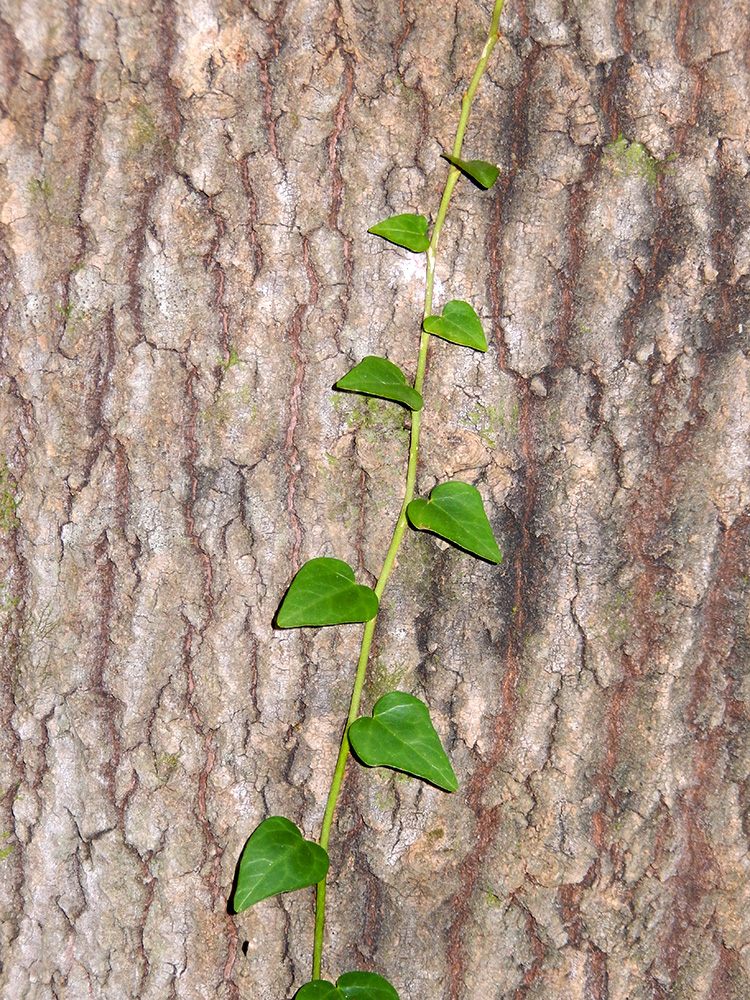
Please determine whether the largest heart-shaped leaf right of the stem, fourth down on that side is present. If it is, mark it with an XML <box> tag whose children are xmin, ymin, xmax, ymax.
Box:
<box><xmin>349</xmin><ymin>691</ymin><xmax>458</xmax><ymax>792</ymax></box>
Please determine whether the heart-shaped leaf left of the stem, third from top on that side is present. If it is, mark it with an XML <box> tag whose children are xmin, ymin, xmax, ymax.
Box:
<box><xmin>276</xmin><ymin>558</ymin><xmax>378</xmax><ymax>628</ymax></box>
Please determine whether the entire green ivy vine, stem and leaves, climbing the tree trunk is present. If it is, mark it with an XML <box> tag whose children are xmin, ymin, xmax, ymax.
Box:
<box><xmin>230</xmin><ymin>0</ymin><xmax>503</xmax><ymax>1000</ymax></box>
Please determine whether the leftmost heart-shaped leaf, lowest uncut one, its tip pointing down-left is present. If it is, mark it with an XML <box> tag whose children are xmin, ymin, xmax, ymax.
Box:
<box><xmin>231</xmin><ymin>816</ymin><xmax>328</xmax><ymax>913</ymax></box>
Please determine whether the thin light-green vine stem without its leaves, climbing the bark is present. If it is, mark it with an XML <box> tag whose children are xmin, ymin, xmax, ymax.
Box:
<box><xmin>313</xmin><ymin>0</ymin><xmax>503</xmax><ymax>979</ymax></box>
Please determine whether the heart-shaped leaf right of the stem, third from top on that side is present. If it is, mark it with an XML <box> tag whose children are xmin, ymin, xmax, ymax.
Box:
<box><xmin>406</xmin><ymin>483</ymin><xmax>503</xmax><ymax>562</ymax></box>
